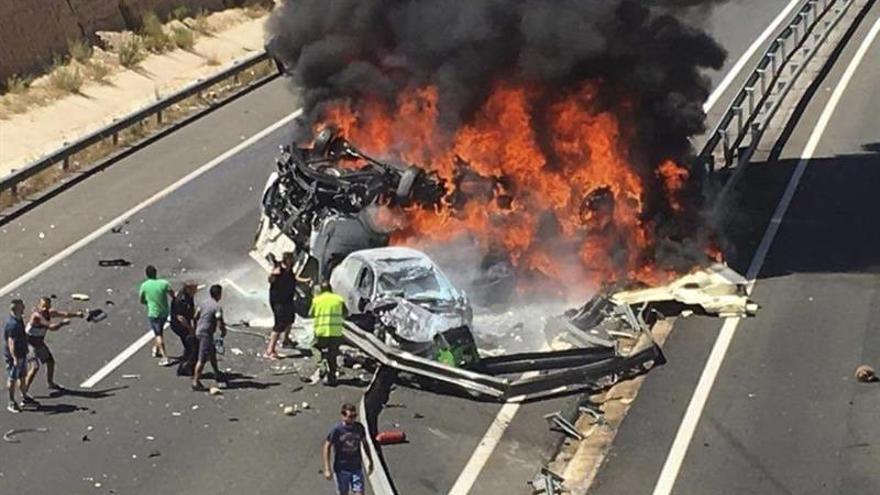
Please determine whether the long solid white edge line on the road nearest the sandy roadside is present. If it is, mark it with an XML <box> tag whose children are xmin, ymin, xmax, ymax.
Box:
<box><xmin>0</xmin><ymin>109</ymin><xmax>302</xmax><ymax>297</ymax></box>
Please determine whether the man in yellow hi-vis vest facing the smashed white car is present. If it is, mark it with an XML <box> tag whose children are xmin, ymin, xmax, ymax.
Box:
<box><xmin>309</xmin><ymin>281</ymin><xmax>345</xmax><ymax>387</ymax></box>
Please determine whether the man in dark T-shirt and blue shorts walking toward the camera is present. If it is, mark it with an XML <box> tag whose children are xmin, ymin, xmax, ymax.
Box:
<box><xmin>323</xmin><ymin>403</ymin><xmax>373</xmax><ymax>495</ymax></box>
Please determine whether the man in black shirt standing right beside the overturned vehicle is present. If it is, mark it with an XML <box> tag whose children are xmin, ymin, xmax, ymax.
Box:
<box><xmin>266</xmin><ymin>251</ymin><xmax>308</xmax><ymax>359</ymax></box>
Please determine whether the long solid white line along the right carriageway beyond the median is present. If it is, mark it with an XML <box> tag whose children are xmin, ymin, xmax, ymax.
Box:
<box><xmin>654</xmin><ymin>19</ymin><xmax>880</xmax><ymax>495</ymax></box>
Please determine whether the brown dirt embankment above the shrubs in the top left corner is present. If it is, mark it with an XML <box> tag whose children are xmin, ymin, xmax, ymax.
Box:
<box><xmin>0</xmin><ymin>0</ymin><xmax>271</xmax><ymax>81</ymax></box>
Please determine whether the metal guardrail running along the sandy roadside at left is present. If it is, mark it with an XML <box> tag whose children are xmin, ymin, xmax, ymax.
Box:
<box><xmin>0</xmin><ymin>51</ymin><xmax>271</xmax><ymax>198</ymax></box>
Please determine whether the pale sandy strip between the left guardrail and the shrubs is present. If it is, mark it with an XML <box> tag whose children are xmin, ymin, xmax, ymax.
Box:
<box><xmin>0</xmin><ymin>11</ymin><xmax>266</xmax><ymax>177</ymax></box>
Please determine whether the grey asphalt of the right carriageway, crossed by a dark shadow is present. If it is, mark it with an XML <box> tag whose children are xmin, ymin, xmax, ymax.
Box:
<box><xmin>591</xmin><ymin>4</ymin><xmax>880</xmax><ymax>495</ymax></box>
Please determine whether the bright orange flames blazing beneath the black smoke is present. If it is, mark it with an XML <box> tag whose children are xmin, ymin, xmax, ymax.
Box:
<box><xmin>316</xmin><ymin>83</ymin><xmax>688</xmax><ymax>286</ymax></box>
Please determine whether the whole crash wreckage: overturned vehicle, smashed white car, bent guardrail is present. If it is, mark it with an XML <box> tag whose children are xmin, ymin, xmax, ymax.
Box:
<box><xmin>251</xmin><ymin>127</ymin><xmax>758</xmax><ymax>402</ymax></box>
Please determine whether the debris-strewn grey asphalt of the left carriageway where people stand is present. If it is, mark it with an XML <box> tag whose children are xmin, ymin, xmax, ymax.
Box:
<box><xmin>0</xmin><ymin>0</ymin><xmax>820</xmax><ymax>495</ymax></box>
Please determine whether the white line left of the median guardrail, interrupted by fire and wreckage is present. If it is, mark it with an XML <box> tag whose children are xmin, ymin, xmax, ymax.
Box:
<box><xmin>449</xmin><ymin>0</ymin><xmax>801</xmax><ymax>495</ymax></box>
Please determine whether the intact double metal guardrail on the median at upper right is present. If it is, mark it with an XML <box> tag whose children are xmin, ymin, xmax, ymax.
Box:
<box><xmin>699</xmin><ymin>0</ymin><xmax>855</xmax><ymax>174</ymax></box>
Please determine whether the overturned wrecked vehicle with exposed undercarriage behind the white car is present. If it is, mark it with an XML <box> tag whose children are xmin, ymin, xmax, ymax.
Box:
<box><xmin>251</xmin><ymin>127</ymin><xmax>445</xmax><ymax>294</ymax></box>
